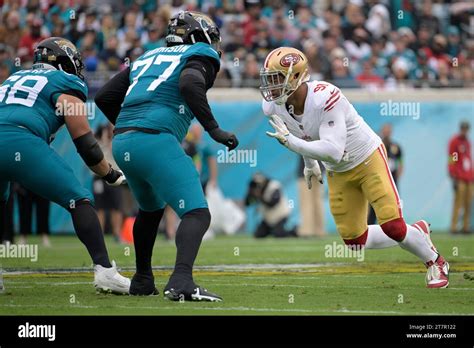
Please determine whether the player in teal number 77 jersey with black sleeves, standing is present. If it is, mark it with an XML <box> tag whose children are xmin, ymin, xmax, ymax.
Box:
<box><xmin>95</xmin><ymin>11</ymin><xmax>238</xmax><ymax>301</ymax></box>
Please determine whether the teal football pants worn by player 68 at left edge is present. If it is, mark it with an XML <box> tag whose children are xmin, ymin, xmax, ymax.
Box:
<box><xmin>0</xmin><ymin>126</ymin><xmax>94</xmax><ymax>209</ymax></box>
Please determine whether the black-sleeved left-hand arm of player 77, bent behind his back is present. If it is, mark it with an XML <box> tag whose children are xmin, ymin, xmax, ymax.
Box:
<box><xmin>94</xmin><ymin>67</ymin><xmax>130</xmax><ymax>125</ymax></box>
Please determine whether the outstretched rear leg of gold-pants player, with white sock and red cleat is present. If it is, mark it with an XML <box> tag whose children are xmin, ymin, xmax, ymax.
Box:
<box><xmin>361</xmin><ymin>146</ymin><xmax>448</xmax><ymax>287</ymax></box>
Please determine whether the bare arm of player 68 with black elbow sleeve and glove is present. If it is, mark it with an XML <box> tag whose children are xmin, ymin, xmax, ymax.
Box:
<box><xmin>57</xmin><ymin>94</ymin><xmax>125</xmax><ymax>185</ymax></box>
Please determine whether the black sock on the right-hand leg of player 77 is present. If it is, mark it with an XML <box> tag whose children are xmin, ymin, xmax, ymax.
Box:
<box><xmin>166</xmin><ymin>208</ymin><xmax>211</xmax><ymax>289</ymax></box>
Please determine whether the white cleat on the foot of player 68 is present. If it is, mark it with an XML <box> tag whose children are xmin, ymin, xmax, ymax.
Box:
<box><xmin>94</xmin><ymin>261</ymin><xmax>130</xmax><ymax>294</ymax></box>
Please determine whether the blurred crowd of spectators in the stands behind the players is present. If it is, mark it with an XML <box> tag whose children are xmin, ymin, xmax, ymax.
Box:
<box><xmin>0</xmin><ymin>0</ymin><xmax>474</xmax><ymax>92</ymax></box>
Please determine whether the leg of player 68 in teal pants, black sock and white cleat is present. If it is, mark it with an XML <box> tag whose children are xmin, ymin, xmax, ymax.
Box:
<box><xmin>1</xmin><ymin>133</ymin><xmax>130</xmax><ymax>293</ymax></box>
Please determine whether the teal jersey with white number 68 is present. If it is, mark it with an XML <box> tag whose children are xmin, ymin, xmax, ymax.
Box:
<box><xmin>0</xmin><ymin>69</ymin><xmax>87</xmax><ymax>142</ymax></box>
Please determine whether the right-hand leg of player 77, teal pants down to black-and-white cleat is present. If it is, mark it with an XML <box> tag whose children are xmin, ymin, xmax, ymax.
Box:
<box><xmin>149</xmin><ymin>134</ymin><xmax>221</xmax><ymax>301</ymax></box>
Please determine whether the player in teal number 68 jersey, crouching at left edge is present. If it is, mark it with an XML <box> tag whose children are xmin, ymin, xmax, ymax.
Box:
<box><xmin>0</xmin><ymin>37</ymin><xmax>130</xmax><ymax>293</ymax></box>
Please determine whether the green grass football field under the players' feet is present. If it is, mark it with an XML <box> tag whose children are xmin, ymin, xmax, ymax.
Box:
<box><xmin>0</xmin><ymin>234</ymin><xmax>474</xmax><ymax>315</ymax></box>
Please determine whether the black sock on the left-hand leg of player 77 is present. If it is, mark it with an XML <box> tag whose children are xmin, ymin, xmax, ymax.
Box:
<box><xmin>133</xmin><ymin>209</ymin><xmax>165</xmax><ymax>274</ymax></box>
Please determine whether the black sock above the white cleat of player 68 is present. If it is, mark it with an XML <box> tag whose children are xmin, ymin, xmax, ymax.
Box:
<box><xmin>70</xmin><ymin>201</ymin><xmax>112</xmax><ymax>268</ymax></box>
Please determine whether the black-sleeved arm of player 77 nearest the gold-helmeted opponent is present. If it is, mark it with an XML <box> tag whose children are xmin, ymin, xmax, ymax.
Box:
<box><xmin>179</xmin><ymin>56</ymin><xmax>239</xmax><ymax>150</ymax></box>
